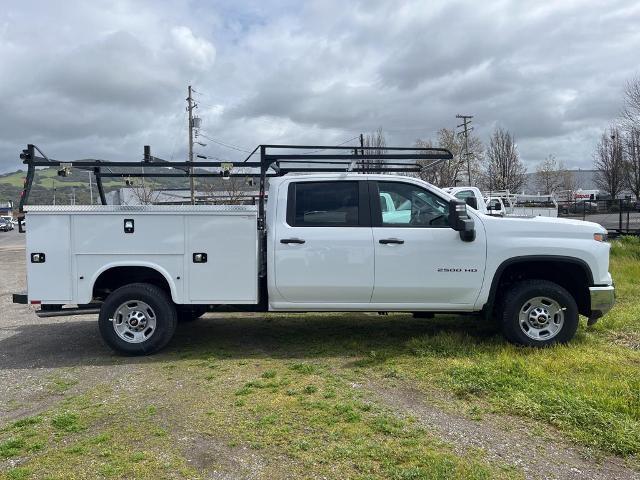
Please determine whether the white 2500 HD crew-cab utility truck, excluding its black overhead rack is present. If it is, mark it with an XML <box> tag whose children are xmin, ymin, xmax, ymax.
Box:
<box><xmin>14</xmin><ymin>144</ymin><xmax>614</xmax><ymax>354</ymax></box>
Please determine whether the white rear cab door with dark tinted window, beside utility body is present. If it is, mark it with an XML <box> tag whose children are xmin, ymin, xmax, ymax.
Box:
<box><xmin>273</xmin><ymin>180</ymin><xmax>374</xmax><ymax>308</ymax></box>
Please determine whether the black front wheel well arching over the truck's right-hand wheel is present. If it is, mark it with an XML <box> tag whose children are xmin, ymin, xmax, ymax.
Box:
<box><xmin>490</xmin><ymin>259</ymin><xmax>592</xmax><ymax>316</ymax></box>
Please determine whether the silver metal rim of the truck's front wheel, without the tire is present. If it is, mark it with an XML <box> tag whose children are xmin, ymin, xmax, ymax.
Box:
<box><xmin>518</xmin><ymin>297</ymin><xmax>565</xmax><ymax>340</ymax></box>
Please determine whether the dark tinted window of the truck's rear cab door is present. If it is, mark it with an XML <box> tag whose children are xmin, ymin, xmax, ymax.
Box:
<box><xmin>288</xmin><ymin>182</ymin><xmax>359</xmax><ymax>227</ymax></box>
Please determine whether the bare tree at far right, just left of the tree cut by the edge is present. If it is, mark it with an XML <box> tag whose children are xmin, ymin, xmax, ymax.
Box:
<box><xmin>594</xmin><ymin>127</ymin><xmax>625</xmax><ymax>198</ymax></box>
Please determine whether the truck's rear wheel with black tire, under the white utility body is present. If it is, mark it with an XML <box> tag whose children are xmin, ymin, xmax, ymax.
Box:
<box><xmin>98</xmin><ymin>283</ymin><xmax>177</xmax><ymax>355</ymax></box>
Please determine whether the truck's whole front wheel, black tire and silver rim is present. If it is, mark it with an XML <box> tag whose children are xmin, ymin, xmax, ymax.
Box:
<box><xmin>499</xmin><ymin>280</ymin><xmax>578</xmax><ymax>347</ymax></box>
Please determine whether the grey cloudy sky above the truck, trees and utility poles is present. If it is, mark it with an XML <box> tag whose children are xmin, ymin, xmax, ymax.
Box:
<box><xmin>0</xmin><ymin>0</ymin><xmax>640</xmax><ymax>172</ymax></box>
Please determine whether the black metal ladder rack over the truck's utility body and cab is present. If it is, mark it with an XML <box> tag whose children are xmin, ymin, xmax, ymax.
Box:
<box><xmin>19</xmin><ymin>144</ymin><xmax>453</xmax><ymax>218</ymax></box>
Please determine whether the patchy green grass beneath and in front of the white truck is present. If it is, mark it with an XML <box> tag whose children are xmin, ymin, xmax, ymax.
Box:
<box><xmin>0</xmin><ymin>238</ymin><xmax>640</xmax><ymax>479</ymax></box>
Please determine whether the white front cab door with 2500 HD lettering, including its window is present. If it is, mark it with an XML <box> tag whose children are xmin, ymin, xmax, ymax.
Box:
<box><xmin>370</xmin><ymin>181</ymin><xmax>486</xmax><ymax>310</ymax></box>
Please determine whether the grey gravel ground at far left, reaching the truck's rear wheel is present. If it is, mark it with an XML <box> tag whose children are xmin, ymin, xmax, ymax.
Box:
<box><xmin>0</xmin><ymin>230</ymin><xmax>127</xmax><ymax>424</ymax></box>
